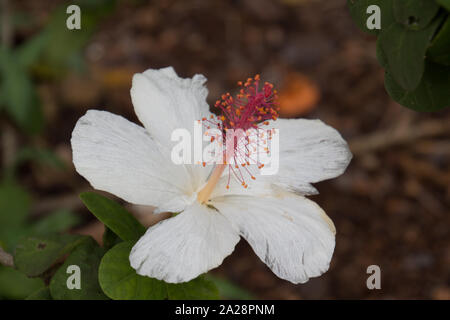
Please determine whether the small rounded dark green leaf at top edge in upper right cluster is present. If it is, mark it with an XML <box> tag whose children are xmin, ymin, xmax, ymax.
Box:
<box><xmin>393</xmin><ymin>0</ymin><xmax>439</xmax><ymax>30</ymax></box>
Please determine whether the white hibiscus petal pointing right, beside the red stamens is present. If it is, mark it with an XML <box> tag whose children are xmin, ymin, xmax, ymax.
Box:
<box><xmin>212</xmin><ymin>119</ymin><xmax>352</xmax><ymax>197</ymax></box>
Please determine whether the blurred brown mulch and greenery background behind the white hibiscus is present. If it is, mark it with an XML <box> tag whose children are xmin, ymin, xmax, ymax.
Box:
<box><xmin>0</xmin><ymin>0</ymin><xmax>450</xmax><ymax>299</ymax></box>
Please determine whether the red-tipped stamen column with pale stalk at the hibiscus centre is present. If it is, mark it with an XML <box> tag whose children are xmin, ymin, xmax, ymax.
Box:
<box><xmin>197</xmin><ymin>75</ymin><xmax>280</xmax><ymax>203</ymax></box>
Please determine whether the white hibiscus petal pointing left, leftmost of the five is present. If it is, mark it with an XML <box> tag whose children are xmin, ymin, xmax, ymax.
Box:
<box><xmin>71</xmin><ymin>110</ymin><xmax>193</xmax><ymax>212</ymax></box>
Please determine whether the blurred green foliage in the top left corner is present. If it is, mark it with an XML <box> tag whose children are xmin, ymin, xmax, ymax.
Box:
<box><xmin>0</xmin><ymin>0</ymin><xmax>116</xmax><ymax>134</ymax></box>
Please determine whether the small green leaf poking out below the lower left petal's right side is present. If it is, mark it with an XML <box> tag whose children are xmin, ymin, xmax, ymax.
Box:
<box><xmin>166</xmin><ymin>276</ymin><xmax>220</xmax><ymax>300</ymax></box>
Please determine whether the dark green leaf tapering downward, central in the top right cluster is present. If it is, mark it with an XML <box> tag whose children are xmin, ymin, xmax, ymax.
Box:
<box><xmin>378</xmin><ymin>19</ymin><xmax>440</xmax><ymax>90</ymax></box>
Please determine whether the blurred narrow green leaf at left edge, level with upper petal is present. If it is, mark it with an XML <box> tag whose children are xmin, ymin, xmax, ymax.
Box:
<box><xmin>0</xmin><ymin>48</ymin><xmax>43</xmax><ymax>134</ymax></box>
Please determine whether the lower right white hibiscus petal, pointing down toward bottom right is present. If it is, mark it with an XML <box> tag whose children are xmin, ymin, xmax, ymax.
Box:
<box><xmin>211</xmin><ymin>193</ymin><xmax>335</xmax><ymax>283</ymax></box>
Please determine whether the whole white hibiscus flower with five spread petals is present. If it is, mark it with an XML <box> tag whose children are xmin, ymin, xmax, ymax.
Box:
<box><xmin>71</xmin><ymin>68</ymin><xmax>351</xmax><ymax>283</ymax></box>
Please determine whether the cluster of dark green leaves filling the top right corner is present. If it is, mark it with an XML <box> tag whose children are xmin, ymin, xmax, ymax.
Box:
<box><xmin>347</xmin><ymin>0</ymin><xmax>450</xmax><ymax>111</ymax></box>
